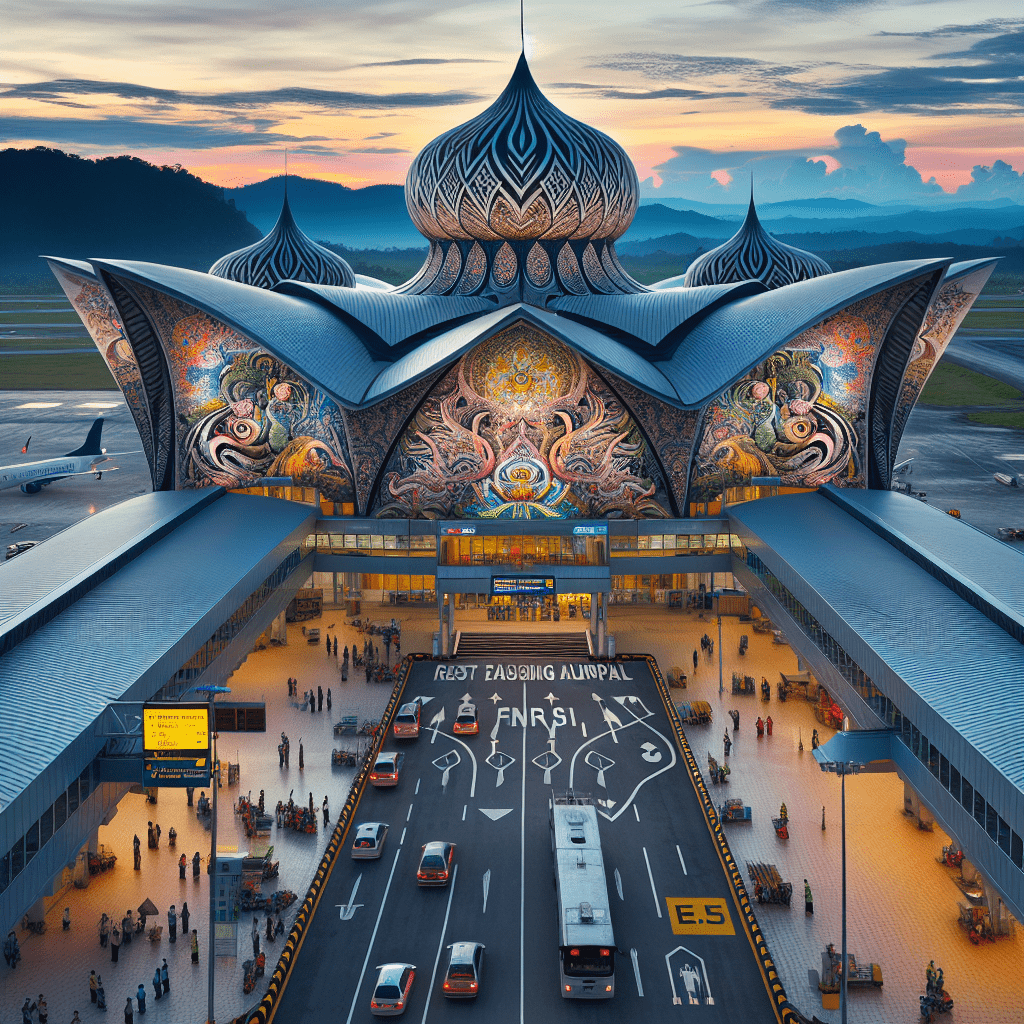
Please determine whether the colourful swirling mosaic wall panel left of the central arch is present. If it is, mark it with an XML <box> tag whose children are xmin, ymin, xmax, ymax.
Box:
<box><xmin>121</xmin><ymin>285</ymin><xmax>354</xmax><ymax>502</ymax></box>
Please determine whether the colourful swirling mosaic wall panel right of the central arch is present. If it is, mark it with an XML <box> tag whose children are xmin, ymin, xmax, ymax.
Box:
<box><xmin>688</xmin><ymin>283</ymin><xmax>912</xmax><ymax>502</ymax></box>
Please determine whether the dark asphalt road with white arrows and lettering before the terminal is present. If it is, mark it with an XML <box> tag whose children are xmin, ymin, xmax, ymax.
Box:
<box><xmin>274</xmin><ymin>662</ymin><xmax>770</xmax><ymax>1024</ymax></box>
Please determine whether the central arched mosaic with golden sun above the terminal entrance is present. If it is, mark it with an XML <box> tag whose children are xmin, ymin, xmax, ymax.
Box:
<box><xmin>373</xmin><ymin>322</ymin><xmax>670</xmax><ymax>519</ymax></box>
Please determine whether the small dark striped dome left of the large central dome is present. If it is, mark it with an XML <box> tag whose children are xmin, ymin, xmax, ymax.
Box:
<box><xmin>210</xmin><ymin>191</ymin><xmax>355</xmax><ymax>289</ymax></box>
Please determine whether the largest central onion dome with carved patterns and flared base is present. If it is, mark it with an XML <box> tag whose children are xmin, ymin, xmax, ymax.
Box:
<box><xmin>399</xmin><ymin>56</ymin><xmax>645</xmax><ymax>301</ymax></box>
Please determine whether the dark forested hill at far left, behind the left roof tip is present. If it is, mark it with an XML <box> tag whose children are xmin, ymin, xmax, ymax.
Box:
<box><xmin>0</xmin><ymin>146</ymin><xmax>260</xmax><ymax>289</ymax></box>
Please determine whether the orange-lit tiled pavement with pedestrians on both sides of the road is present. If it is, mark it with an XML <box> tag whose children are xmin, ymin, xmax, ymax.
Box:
<box><xmin>0</xmin><ymin>601</ymin><xmax>1024</xmax><ymax>1024</ymax></box>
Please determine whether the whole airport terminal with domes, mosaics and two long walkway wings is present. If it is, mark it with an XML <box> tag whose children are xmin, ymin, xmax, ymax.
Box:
<box><xmin>0</xmin><ymin>58</ymin><xmax>1024</xmax><ymax>942</ymax></box>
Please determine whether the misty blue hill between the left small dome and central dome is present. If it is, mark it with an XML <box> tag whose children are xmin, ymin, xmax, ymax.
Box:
<box><xmin>224</xmin><ymin>175</ymin><xmax>426</xmax><ymax>249</ymax></box>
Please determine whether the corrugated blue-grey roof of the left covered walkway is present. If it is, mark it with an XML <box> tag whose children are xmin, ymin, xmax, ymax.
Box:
<box><xmin>0</xmin><ymin>488</ymin><xmax>318</xmax><ymax>806</ymax></box>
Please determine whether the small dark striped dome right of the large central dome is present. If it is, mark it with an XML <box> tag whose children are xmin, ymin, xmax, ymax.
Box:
<box><xmin>683</xmin><ymin>194</ymin><xmax>833</xmax><ymax>288</ymax></box>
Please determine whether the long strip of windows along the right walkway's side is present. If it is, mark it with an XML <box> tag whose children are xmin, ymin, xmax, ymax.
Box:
<box><xmin>746</xmin><ymin>551</ymin><xmax>1024</xmax><ymax>870</ymax></box>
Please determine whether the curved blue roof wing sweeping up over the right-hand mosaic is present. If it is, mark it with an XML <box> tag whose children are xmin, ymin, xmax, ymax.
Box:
<box><xmin>658</xmin><ymin>259</ymin><xmax>950</xmax><ymax>407</ymax></box>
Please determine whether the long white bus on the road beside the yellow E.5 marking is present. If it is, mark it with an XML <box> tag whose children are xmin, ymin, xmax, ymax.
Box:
<box><xmin>551</xmin><ymin>794</ymin><xmax>615</xmax><ymax>999</ymax></box>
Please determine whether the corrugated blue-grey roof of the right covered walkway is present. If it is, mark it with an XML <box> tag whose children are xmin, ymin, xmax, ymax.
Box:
<box><xmin>729</xmin><ymin>491</ymin><xmax>1024</xmax><ymax>788</ymax></box>
